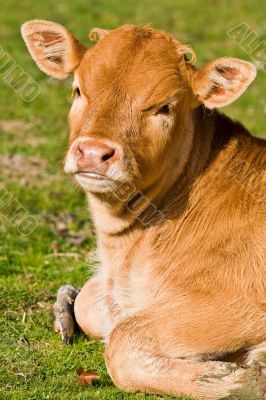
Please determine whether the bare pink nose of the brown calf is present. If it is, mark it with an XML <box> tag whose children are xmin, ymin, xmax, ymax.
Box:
<box><xmin>74</xmin><ymin>140</ymin><xmax>116</xmax><ymax>174</ymax></box>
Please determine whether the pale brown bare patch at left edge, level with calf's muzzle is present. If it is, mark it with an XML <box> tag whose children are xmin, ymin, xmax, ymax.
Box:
<box><xmin>0</xmin><ymin>154</ymin><xmax>51</xmax><ymax>186</ymax></box>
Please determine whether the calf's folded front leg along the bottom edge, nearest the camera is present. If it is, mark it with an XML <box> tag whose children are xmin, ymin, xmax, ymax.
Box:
<box><xmin>105</xmin><ymin>299</ymin><xmax>264</xmax><ymax>400</ymax></box>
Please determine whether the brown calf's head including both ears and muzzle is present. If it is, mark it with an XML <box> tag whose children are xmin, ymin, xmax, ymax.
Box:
<box><xmin>22</xmin><ymin>20</ymin><xmax>256</xmax><ymax>195</ymax></box>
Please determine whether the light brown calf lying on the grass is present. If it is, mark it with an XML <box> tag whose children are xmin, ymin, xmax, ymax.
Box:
<box><xmin>22</xmin><ymin>20</ymin><xmax>266</xmax><ymax>400</ymax></box>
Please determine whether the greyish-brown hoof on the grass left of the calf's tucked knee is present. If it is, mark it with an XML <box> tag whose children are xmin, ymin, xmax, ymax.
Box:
<box><xmin>53</xmin><ymin>285</ymin><xmax>79</xmax><ymax>344</ymax></box>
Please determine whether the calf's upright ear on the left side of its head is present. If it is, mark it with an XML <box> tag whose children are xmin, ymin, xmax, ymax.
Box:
<box><xmin>21</xmin><ymin>20</ymin><xmax>86</xmax><ymax>79</ymax></box>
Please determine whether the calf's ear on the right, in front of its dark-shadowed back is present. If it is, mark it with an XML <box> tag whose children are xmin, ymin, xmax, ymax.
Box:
<box><xmin>192</xmin><ymin>57</ymin><xmax>256</xmax><ymax>108</ymax></box>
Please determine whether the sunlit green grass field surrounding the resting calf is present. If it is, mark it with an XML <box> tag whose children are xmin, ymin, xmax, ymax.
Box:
<box><xmin>0</xmin><ymin>0</ymin><xmax>266</xmax><ymax>400</ymax></box>
